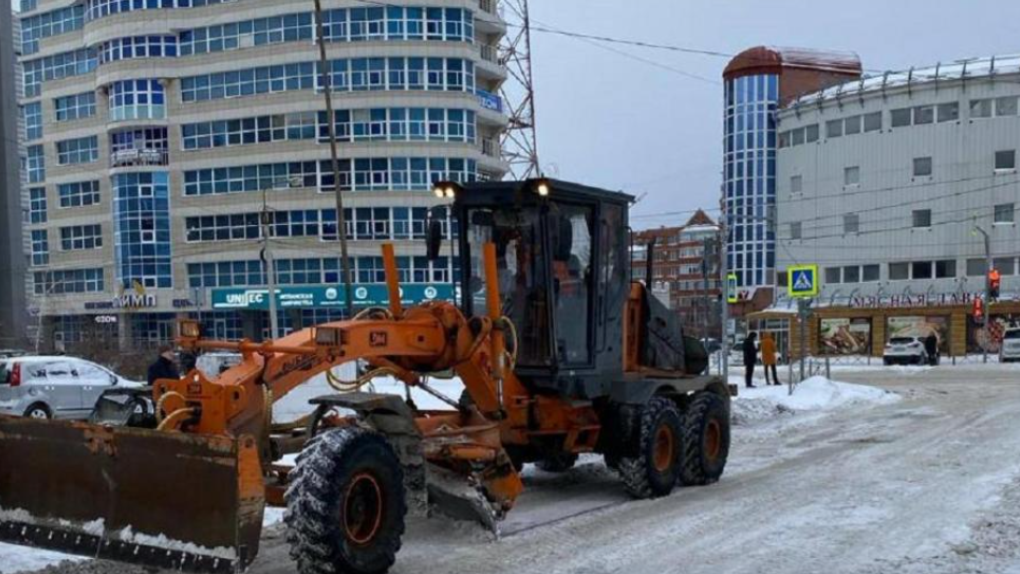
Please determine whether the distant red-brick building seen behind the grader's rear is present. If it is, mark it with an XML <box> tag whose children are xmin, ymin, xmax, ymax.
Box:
<box><xmin>631</xmin><ymin>210</ymin><xmax>722</xmax><ymax>337</ymax></box>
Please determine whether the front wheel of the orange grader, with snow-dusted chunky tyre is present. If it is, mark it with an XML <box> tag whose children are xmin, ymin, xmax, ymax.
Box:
<box><xmin>284</xmin><ymin>427</ymin><xmax>407</xmax><ymax>574</ymax></box>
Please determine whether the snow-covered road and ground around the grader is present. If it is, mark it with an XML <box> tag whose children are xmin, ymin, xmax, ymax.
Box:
<box><xmin>11</xmin><ymin>365</ymin><xmax>1020</xmax><ymax>574</ymax></box>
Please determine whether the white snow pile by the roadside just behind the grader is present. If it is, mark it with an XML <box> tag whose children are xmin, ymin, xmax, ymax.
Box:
<box><xmin>732</xmin><ymin>376</ymin><xmax>900</xmax><ymax>424</ymax></box>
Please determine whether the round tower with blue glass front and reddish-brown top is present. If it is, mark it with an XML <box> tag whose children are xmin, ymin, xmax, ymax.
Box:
<box><xmin>722</xmin><ymin>46</ymin><xmax>861</xmax><ymax>315</ymax></box>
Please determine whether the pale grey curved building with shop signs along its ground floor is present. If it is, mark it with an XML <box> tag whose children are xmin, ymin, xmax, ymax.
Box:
<box><xmin>766</xmin><ymin>56</ymin><xmax>1020</xmax><ymax>356</ymax></box>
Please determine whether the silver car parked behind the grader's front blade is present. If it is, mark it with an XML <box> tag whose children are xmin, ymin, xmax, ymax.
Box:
<box><xmin>0</xmin><ymin>356</ymin><xmax>142</xmax><ymax>419</ymax></box>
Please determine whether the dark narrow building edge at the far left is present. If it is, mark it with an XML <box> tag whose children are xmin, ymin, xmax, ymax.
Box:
<box><xmin>0</xmin><ymin>7</ymin><xmax>28</xmax><ymax>347</ymax></box>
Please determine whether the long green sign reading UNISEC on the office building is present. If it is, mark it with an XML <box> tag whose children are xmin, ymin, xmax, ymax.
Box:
<box><xmin>212</xmin><ymin>284</ymin><xmax>455</xmax><ymax>311</ymax></box>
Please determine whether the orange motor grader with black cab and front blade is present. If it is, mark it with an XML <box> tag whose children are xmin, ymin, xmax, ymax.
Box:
<box><xmin>0</xmin><ymin>179</ymin><xmax>731</xmax><ymax>574</ymax></box>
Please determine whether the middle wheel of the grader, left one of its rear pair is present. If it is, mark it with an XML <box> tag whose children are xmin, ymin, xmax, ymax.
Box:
<box><xmin>619</xmin><ymin>397</ymin><xmax>683</xmax><ymax>499</ymax></box>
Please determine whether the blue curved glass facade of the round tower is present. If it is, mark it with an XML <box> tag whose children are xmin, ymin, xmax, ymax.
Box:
<box><xmin>723</xmin><ymin>74</ymin><xmax>779</xmax><ymax>288</ymax></box>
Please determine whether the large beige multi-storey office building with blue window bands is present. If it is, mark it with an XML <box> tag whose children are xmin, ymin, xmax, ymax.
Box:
<box><xmin>20</xmin><ymin>0</ymin><xmax>508</xmax><ymax>343</ymax></box>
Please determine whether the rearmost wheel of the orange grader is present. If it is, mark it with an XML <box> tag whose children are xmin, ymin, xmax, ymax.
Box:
<box><xmin>680</xmin><ymin>392</ymin><xmax>729</xmax><ymax>486</ymax></box>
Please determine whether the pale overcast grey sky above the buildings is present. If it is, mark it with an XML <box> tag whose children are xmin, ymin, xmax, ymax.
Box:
<box><xmin>12</xmin><ymin>0</ymin><xmax>1020</xmax><ymax>227</ymax></box>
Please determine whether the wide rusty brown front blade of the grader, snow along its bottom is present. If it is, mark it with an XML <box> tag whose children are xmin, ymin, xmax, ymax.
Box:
<box><xmin>0</xmin><ymin>416</ymin><xmax>265</xmax><ymax>573</ymax></box>
